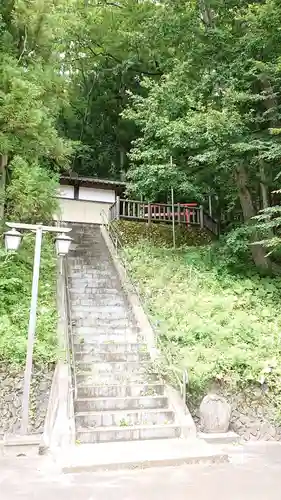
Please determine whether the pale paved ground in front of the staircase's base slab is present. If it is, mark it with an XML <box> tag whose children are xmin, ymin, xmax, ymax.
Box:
<box><xmin>0</xmin><ymin>443</ymin><xmax>281</xmax><ymax>500</ymax></box>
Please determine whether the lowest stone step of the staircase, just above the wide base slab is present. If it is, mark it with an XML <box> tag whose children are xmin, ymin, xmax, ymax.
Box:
<box><xmin>76</xmin><ymin>424</ymin><xmax>181</xmax><ymax>444</ymax></box>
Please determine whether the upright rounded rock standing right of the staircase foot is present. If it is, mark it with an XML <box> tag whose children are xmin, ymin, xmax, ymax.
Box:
<box><xmin>200</xmin><ymin>394</ymin><xmax>231</xmax><ymax>433</ymax></box>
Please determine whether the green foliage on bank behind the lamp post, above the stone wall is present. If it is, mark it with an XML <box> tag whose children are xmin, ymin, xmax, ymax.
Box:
<box><xmin>0</xmin><ymin>235</ymin><xmax>57</xmax><ymax>366</ymax></box>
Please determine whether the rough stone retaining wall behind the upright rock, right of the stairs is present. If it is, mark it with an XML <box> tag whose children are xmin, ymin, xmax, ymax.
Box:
<box><xmin>191</xmin><ymin>389</ymin><xmax>281</xmax><ymax>441</ymax></box>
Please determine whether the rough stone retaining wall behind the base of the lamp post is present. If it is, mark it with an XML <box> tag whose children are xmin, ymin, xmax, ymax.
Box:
<box><xmin>0</xmin><ymin>365</ymin><xmax>54</xmax><ymax>435</ymax></box>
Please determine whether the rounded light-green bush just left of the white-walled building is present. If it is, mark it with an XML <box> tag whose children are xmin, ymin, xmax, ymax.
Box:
<box><xmin>6</xmin><ymin>157</ymin><xmax>58</xmax><ymax>224</ymax></box>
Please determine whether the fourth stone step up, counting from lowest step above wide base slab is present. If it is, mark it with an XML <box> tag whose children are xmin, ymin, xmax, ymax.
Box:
<box><xmin>77</xmin><ymin>382</ymin><xmax>165</xmax><ymax>398</ymax></box>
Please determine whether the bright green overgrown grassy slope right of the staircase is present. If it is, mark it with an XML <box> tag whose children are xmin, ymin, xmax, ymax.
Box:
<box><xmin>125</xmin><ymin>242</ymin><xmax>281</xmax><ymax>414</ymax></box>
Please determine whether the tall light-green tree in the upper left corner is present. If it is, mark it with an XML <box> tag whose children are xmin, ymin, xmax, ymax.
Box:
<box><xmin>0</xmin><ymin>0</ymin><xmax>75</xmax><ymax>216</ymax></box>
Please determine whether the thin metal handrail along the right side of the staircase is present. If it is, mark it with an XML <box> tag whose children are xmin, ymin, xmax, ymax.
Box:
<box><xmin>100</xmin><ymin>210</ymin><xmax>189</xmax><ymax>405</ymax></box>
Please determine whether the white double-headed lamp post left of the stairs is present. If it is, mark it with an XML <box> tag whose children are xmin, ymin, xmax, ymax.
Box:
<box><xmin>4</xmin><ymin>222</ymin><xmax>72</xmax><ymax>434</ymax></box>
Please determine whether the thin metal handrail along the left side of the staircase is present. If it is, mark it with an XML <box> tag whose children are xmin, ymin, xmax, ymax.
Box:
<box><xmin>63</xmin><ymin>257</ymin><xmax>77</xmax><ymax>400</ymax></box>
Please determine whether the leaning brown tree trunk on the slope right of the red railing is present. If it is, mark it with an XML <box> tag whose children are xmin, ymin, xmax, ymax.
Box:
<box><xmin>236</xmin><ymin>166</ymin><xmax>271</xmax><ymax>271</ymax></box>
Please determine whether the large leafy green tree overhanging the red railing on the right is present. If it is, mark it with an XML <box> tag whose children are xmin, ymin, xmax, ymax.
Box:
<box><xmin>125</xmin><ymin>0</ymin><xmax>281</xmax><ymax>268</ymax></box>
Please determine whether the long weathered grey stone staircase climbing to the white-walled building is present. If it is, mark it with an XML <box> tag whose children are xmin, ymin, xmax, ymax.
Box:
<box><xmin>69</xmin><ymin>225</ymin><xmax>182</xmax><ymax>443</ymax></box>
